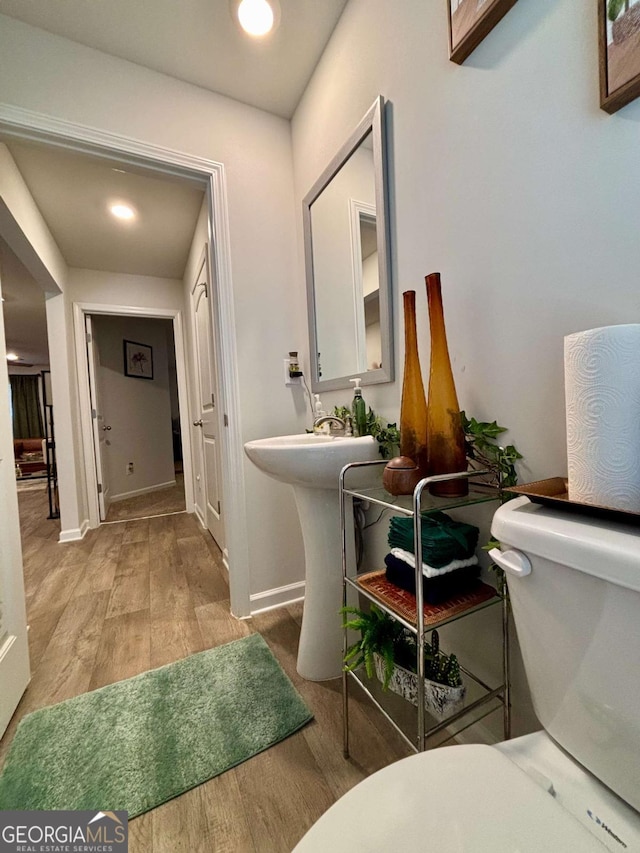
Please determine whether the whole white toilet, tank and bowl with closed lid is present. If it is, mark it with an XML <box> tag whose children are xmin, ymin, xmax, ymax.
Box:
<box><xmin>295</xmin><ymin>497</ymin><xmax>640</xmax><ymax>853</ymax></box>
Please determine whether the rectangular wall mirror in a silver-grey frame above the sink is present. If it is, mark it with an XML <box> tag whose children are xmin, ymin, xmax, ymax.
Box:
<box><xmin>303</xmin><ymin>97</ymin><xmax>394</xmax><ymax>391</ymax></box>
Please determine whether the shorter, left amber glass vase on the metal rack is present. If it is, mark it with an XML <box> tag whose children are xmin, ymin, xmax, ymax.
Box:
<box><xmin>400</xmin><ymin>290</ymin><xmax>427</xmax><ymax>477</ymax></box>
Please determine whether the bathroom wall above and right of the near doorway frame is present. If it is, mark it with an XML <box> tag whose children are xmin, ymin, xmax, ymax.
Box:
<box><xmin>0</xmin><ymin>16</ymin><xmax>310</xmax><ymax>592</ymax></box>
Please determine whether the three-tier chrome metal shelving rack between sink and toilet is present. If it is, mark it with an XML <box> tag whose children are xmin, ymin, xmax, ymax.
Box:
<box><xmin>340</xmin><ymin>460</ymin><xmax>511</xmax><ymax>757</ymax></box>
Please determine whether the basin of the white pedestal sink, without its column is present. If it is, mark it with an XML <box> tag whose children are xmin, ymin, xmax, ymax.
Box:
<box><xmin>244</xmin><ymin>433</ymin><xmax>379</xmax><ymax>489</ymax></box>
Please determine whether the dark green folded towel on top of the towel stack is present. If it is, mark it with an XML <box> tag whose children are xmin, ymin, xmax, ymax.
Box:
<box><xmin>388</xmin><ymin>512</ymin><xmax>480</xmax><ymax>569</ymax></box>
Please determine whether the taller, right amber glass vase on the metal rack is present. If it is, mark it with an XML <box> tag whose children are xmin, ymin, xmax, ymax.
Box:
<box><xmin>425</xmin><ymin>272</ymin><xmax>469</xmax><ymax>497</ymax></box>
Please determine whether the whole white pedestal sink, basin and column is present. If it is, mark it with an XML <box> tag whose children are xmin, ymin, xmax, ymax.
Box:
<box><xmin>244</xmin><ymin>434</ymin><xmax>379</xmax><ymax>681</ymax></box>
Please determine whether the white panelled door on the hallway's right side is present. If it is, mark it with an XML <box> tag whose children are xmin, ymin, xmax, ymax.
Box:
<box><xmin>191</xmin><ymin>247</ymin><xmax>224</xmax><ymax>550</ymax></box>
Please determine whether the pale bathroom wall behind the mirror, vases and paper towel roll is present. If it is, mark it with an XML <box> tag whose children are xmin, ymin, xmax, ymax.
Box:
<box><xmin>292</xmin><ymin>0</ymin><xmax>640</xmax><ymax>732</ymax></box>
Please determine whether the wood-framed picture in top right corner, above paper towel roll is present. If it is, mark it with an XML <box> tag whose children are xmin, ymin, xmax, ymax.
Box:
<box><xmin>598</xmin><ymin>0</ymin><xmax>640</xmax><ymax>113</ymax></box>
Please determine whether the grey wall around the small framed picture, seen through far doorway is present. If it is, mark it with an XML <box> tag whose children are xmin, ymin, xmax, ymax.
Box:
<box><xmin>92</xmin><ymin>315</ymin><xmax>175</xmax><ymax>500</ymax></box>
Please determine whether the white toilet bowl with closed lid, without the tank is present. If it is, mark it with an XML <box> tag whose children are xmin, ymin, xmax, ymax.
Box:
<box><xmin>294</xmin><ymin>732</ymin><xmax>640</xmax><ymax>853</ymax></box>
